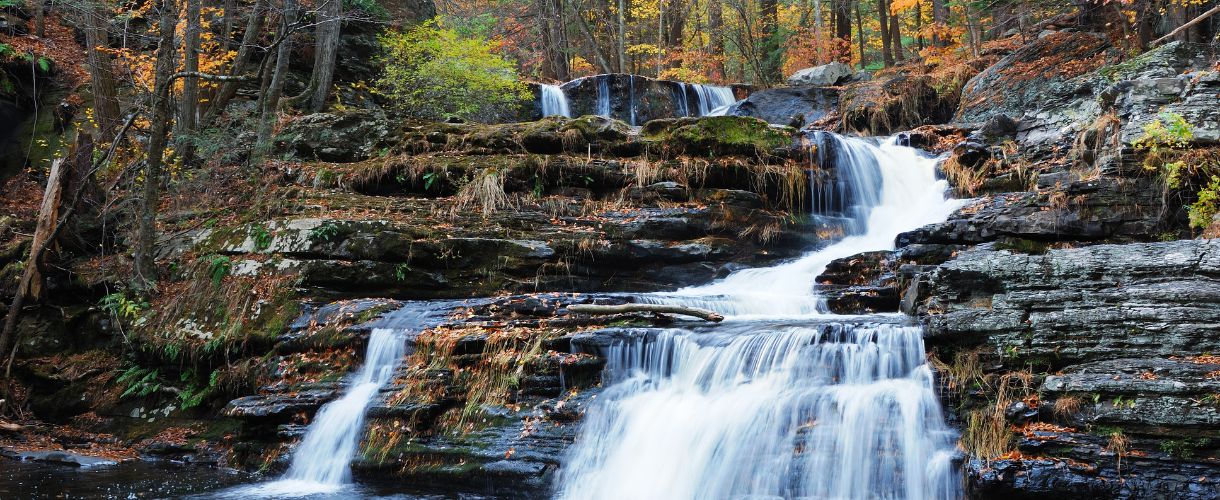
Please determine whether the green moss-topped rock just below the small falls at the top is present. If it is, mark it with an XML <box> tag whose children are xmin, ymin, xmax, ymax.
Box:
<box><xmin>641</xmin><ymin>116</ymin><xmax>795</xmax><ymax>156</ymax></box>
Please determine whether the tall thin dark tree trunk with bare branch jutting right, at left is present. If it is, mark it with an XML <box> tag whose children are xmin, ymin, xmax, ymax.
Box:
<box><xmin>133</xmin><ymin>0</ymin><xmax>178</xmax><ymax>290</ymax></box>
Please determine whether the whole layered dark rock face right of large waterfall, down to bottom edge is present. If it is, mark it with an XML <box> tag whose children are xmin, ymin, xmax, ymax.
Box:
<box><xmin>915</xmin><ymin>240</ymin><xmax>1220</xmax><ymax>499</ymax></box>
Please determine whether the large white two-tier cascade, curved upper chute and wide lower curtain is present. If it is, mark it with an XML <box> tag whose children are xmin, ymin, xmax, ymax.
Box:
<box><xmin>556</xmin><ymin>131</ymin><xmax>960</xmax><ymax>499</ymax></box>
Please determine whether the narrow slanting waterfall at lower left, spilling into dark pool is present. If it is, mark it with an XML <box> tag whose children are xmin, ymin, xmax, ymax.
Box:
<box><xmin>217</xmin><ymin>301</ymin><xmax>451</xmax><ymax>498</ymax></box>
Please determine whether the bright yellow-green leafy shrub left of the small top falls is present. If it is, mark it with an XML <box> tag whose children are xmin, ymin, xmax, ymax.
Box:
<box><xmin>377</xmin><ymin>20</ymin><xmax>532</xmax><ymax>122</ymax></box>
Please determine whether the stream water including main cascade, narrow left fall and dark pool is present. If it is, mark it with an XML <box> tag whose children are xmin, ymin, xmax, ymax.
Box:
<box><xmin>0</xmin><ymin>131</ymin><xmax>961</xmax><ymax>499</ymax></box>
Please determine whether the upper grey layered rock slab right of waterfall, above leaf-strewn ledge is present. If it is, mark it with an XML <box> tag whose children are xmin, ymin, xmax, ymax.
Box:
<box><xmin>925</xmin><ymin>240</ymin><xmax>1220</xmax><ymax>367</ymax></box>
